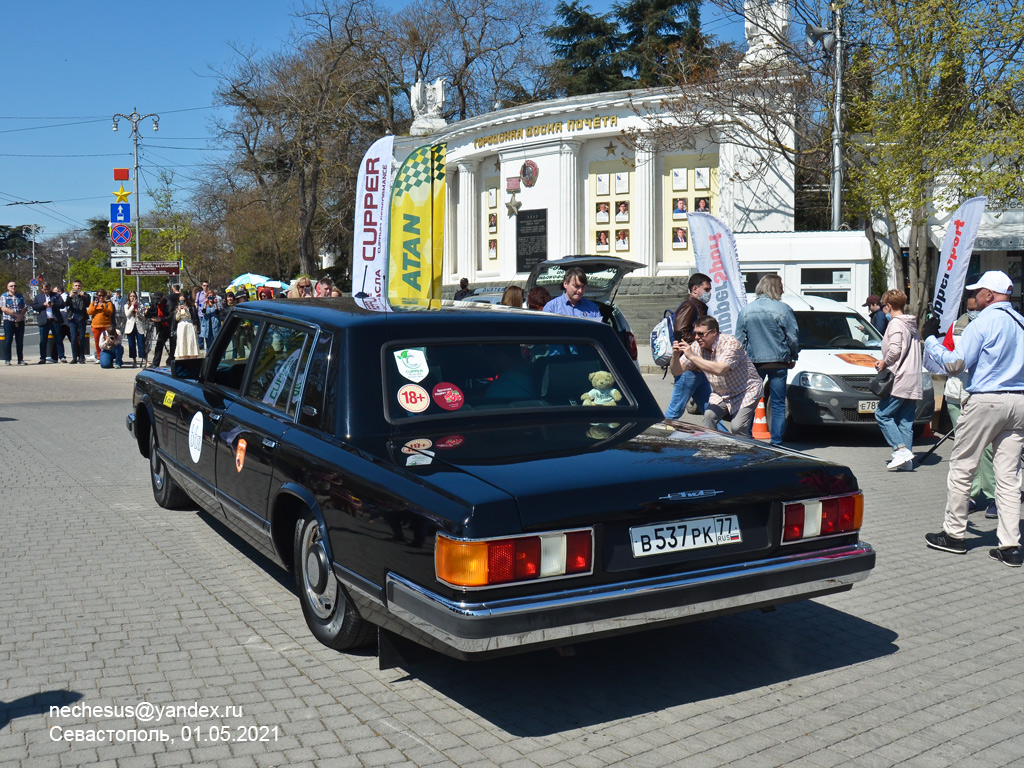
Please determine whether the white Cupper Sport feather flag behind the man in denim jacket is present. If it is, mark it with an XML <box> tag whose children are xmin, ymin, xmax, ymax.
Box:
<box><xmin>688</xmin><ymin>212</ymin><xmax>746</xmax><ymax>334</ymax></box>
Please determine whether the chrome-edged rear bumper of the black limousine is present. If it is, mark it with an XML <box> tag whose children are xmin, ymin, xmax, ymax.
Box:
<box><xmin>385</xmin><ymin>542</ymin><xmax>874</xmax><ymax>657</ymax></box>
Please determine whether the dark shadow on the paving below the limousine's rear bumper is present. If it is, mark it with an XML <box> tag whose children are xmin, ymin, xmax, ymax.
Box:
<box><xmin>407</xmin><ymin>601</ymin><xmax>898</xmax><ymax>736</ymax></box>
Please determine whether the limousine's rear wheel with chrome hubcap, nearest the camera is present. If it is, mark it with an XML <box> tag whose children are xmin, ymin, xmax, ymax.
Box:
<box><xmin>294</xmin><ymin>512</ymin><xmax>377</xmax><ymax>650</ymax></box>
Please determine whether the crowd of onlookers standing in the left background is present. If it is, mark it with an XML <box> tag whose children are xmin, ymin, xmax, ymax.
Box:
<box><xmin>0</xmin><ymin>274</ymin><xmax>341</xmax><ymax>369</ymax></box>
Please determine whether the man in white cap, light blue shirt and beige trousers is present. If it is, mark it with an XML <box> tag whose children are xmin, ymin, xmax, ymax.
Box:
<box><xmin>923</xmin><ymin>271</ymin><xmax>1024</xmax><ymax>567</ymax></box>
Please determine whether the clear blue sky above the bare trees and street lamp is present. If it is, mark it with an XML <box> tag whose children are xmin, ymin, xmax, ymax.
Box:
<box><xmin>0</xmin><ymin>0</ymin><xmax>742</xmax><ymax>239</ymax></box>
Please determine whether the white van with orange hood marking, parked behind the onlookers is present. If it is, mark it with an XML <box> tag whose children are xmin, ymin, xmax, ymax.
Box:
<box><xmin>770</xmin><ymin>293</ymin><xmax>935</xmax><ymax>435</ymax></box>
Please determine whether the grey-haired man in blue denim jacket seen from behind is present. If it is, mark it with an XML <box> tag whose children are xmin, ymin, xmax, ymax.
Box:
<box><xmin>736</xmin><ymin>274</ymin><xmax>800</xmax><ymax>445</ymax></box>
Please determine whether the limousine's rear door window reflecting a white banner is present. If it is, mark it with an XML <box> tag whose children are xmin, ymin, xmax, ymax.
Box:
<box><xmin>246</xmin><ymin>324</ymin><xmax>311</xmax><ymax>416</ymax></box>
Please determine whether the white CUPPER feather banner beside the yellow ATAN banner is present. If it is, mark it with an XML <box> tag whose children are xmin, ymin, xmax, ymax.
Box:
<box><xmin>352</xmin><ymin>136</ymin><xmax>394</xmax><ymax>312</ymax></box>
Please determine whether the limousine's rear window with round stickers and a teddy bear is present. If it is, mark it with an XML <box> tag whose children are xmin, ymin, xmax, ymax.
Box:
<box><xmin>384</xmin><ymin>340</ymin><xmax>635</xmax><ymax>421</ymax></box>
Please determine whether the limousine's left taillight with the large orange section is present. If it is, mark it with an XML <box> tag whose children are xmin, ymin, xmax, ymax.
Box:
<box><xmin>434</xmin><ymin>528</ymin><xmax>594</xmax><ymax>587</ymax></box>
